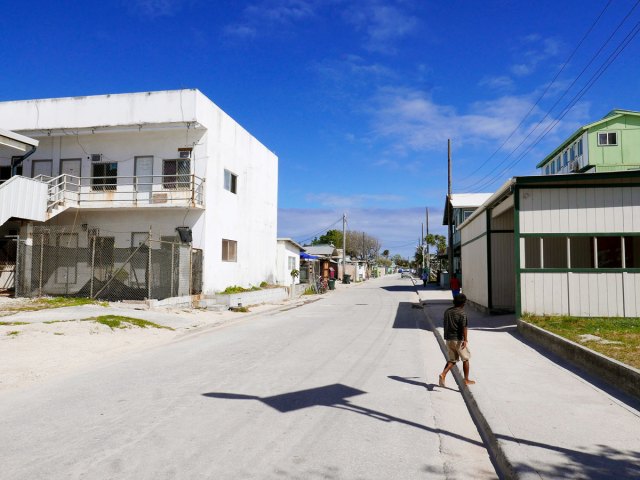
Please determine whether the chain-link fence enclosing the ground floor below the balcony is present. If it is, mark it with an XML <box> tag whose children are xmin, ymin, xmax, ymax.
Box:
<box><xmin>15</xmin><ymin>226</ymin><xmax>202</xmax><ymax>301</ymax></box>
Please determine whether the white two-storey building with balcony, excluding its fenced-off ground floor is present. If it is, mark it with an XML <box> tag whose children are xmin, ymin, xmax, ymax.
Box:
<box><xmin>0</xmin><ymin>89</ymin><xmax>278</xmax><ymax>293</ymax></box>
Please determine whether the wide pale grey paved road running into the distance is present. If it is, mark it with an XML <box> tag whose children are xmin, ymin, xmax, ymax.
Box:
<box><xmin>0</xmin><ymin>276</ymin><xmax>496</xmax><ymax>480</ymax></box>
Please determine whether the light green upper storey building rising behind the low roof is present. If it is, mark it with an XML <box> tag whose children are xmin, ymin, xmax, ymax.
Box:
<box><xmin>536</xmin><ymin>110</ymin><xmax>640</xmax><ymax>175</ymax></box>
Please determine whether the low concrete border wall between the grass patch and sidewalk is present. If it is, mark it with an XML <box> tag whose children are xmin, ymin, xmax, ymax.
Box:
<box><xmin>517</xmin><ymin>319</ymin><xmax>640</xmax><ymax>401</ymax></box>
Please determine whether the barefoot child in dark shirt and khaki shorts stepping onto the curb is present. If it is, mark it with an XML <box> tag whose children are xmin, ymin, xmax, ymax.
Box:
<box><xmin>438</xmin><ymin>293</ymin><xmax>476</xmax><ymax>387</ymax></box>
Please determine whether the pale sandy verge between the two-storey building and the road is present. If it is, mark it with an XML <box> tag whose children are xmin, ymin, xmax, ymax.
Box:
<box><xmin>0</xmin><ymin>296</ymin><xmax>314</xmax><ymax>394</ymax></box>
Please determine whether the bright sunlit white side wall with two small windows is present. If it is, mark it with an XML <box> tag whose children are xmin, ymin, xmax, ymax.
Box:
<box><xmin>196</xmin><ymin>92</ymin><xmax>278</xmax><ymax>293</ymax></box>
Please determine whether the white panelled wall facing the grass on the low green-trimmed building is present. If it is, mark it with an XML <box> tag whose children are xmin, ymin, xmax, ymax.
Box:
<box><xmin>520</xmin><ymin>186</ymin><xmax>640</xmax><ymax>317</ymax></box>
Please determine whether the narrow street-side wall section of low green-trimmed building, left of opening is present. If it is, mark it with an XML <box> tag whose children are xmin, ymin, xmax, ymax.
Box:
<box><xmin>460</xmin><ymin>211</ymin><xmax>489</xmax><ymax>307</ymax></box>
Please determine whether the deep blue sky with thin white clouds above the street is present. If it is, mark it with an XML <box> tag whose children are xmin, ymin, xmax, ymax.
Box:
<box><xmin>0</xmin><ymin>0</ymin><xmax>640</xmax><ymax>256</ymax></box>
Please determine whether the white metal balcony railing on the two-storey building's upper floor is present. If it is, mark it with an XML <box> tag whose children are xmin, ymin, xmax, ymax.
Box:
<box><xmin>36</xmin><ymin>174</ymin><xmax>204</xmax><ymax>211</ymax></box>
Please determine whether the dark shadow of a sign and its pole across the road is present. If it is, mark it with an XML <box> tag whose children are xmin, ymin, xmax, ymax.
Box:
<box><xmin>202</xmin><ymin>377</ymin><xmax>484</xmax><ymax>447</ymax></box>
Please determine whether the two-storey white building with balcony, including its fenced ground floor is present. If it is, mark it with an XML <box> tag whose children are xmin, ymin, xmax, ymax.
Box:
<box><xmin>0</xmin><ymin>89</ymin><xmax>278</xmax><ymax>298</ymax></box>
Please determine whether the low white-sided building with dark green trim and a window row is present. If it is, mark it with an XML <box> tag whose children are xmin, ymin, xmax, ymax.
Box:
<box><xmin>459</xmin><ymin>171</ymin><xmax>640</xmax><ymax>317</ymax></box>
